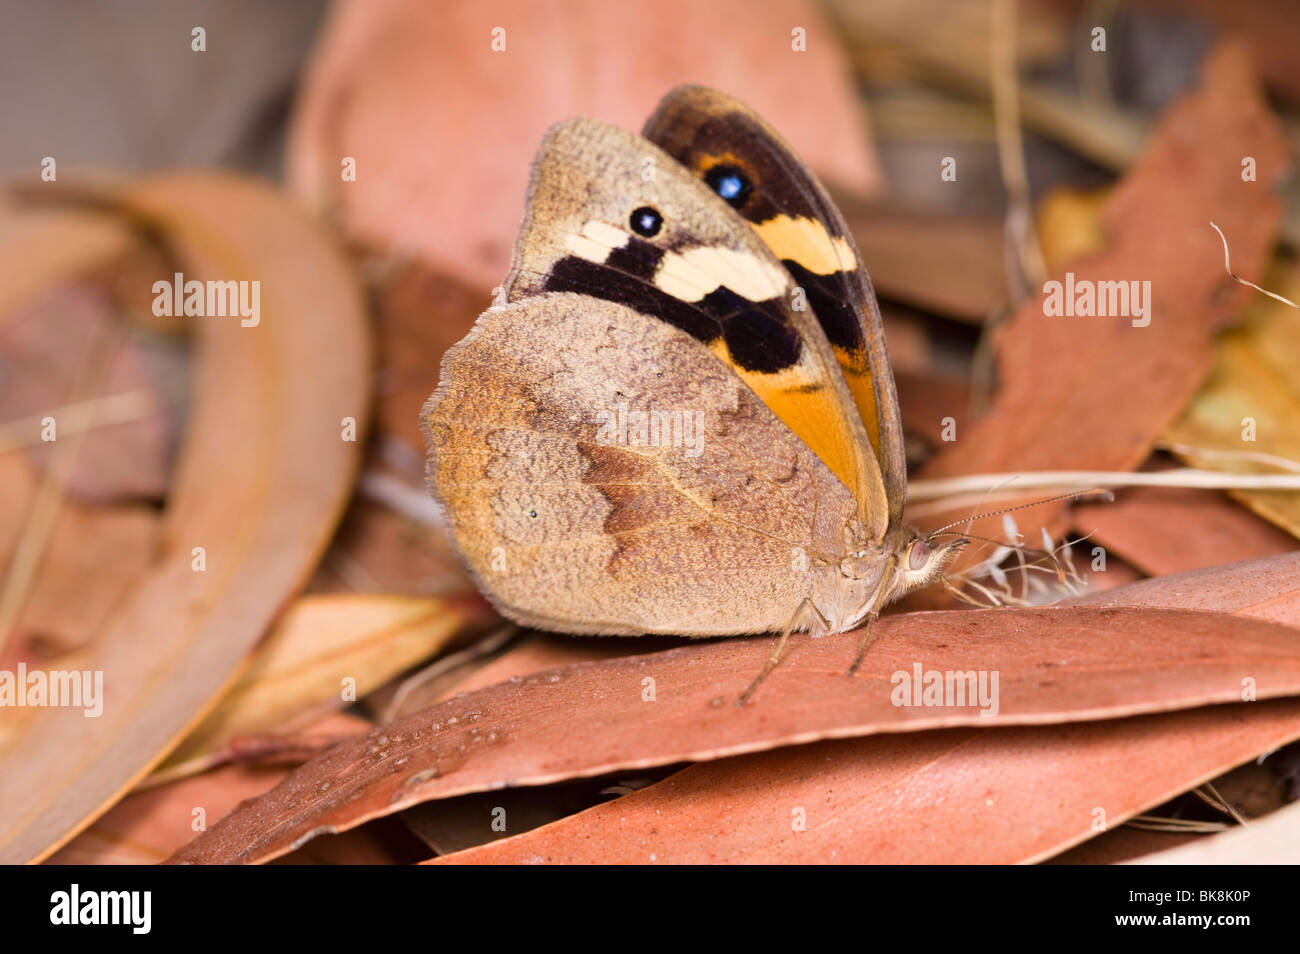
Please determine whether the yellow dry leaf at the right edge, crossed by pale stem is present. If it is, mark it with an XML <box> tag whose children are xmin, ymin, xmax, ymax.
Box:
<box><xmin>1165</xmin><ymin>265</ymin><xmax>1300</xmax><ymax>537</ymax></box>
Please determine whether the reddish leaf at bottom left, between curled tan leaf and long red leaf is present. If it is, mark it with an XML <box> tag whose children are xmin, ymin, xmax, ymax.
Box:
<box><xmin>46</xmin><ymin>712</ymin><xmax>371</xmax><ymax>864</ymax></box>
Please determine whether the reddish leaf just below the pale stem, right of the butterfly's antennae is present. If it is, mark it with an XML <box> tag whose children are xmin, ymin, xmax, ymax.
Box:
<box><xmin>1071</xmin><ymin>487</ymin><xmax>1300</xmax><ymax>576</ymax></box>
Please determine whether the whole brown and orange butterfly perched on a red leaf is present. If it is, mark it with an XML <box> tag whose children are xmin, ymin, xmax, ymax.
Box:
<box><xmin>423</xmin><ymin>86</ymin><xmax>966</xmax><ymax>702</ymax></box>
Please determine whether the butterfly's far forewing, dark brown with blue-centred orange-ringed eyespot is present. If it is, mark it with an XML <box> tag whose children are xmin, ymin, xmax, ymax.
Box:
<box><xmin>644</xmin><ymin>86</ymin><xmax>906</xmax><ymax>526</ymax></box>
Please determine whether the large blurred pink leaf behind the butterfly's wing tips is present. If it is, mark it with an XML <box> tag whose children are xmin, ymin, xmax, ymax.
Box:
<box><xmin>286</xmin><ymin>0</ymin><xmax>881</xmax><ymax>290</ymax></box>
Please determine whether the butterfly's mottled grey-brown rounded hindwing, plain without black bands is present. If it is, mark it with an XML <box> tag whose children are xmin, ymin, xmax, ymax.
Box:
<box><xmin>423</xmin><ymin>292</ymin><xmax>857</xmax><ymax>636</ymax></box>
